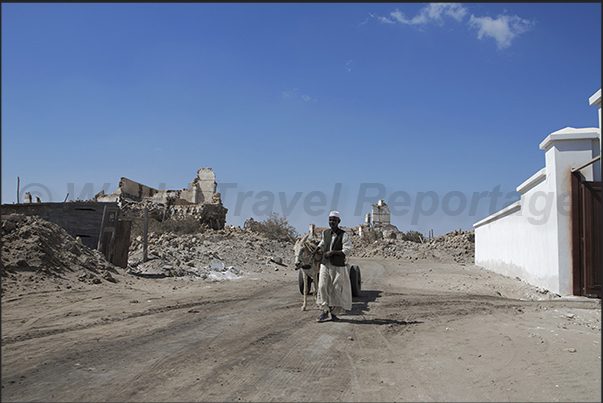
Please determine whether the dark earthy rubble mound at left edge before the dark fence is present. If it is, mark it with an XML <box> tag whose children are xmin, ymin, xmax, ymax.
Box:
<box><xmin>2</xmin><ymin>214</ymin><xmax>118</xmax><ymax>283</ymax></box>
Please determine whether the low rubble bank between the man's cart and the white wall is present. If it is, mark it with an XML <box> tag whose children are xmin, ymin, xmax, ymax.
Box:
<box><xmin>351</xmin><ymin>230</ymin><xmax>475</xmax><ymax>263</ymax></box>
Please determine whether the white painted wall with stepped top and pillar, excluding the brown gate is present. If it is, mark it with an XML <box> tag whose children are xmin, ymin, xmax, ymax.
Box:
<box><xmin>473</xmin><ymin>90</ymin><xmax>601</xmax><ymax>295</ymax></box>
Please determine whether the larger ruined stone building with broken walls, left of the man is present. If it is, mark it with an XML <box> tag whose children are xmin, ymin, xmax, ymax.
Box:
<box><xmin>94</xmin><ymin>168</ymin><xmax>228</xmax><ymax>229</ymax></box>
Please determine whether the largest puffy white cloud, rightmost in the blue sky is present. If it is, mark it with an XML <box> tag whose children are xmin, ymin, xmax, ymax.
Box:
<box><xmin>469</xmin><ymin>15</ymin><xmax>534</xmax><ymax>49</ymax></box>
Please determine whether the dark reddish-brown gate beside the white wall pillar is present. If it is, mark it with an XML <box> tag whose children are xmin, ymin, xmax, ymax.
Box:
<box><xmin>571</xmin><ymin>172</ymin><xmax>603</xmax><ymax>298</ymax></box>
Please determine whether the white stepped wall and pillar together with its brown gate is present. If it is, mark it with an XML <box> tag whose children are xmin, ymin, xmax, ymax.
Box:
<box><xmin>473</xmin><ymin>89</ymin><xmax>601</xmax><ymax>297</ymax></box>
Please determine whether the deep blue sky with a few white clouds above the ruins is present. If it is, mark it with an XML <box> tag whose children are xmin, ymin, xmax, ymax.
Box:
<box><xmin>2</xmin><ymin>3</ymin><xmax>601</xmax><ymax>235</ymax></box>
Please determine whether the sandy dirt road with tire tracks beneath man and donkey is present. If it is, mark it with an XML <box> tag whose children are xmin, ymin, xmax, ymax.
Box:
<box><xmin>2</xmin><ymin>259</ymin><xmax>601</xmax><ymax>402</ymax></box>
